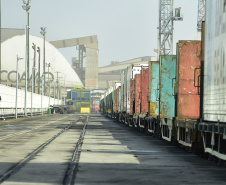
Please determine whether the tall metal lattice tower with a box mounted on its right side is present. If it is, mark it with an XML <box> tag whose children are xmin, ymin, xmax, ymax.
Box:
<box><xmin>158</xmin><ymin>0</ymin><xmax>183</xmax><ymax>55</ymax></box>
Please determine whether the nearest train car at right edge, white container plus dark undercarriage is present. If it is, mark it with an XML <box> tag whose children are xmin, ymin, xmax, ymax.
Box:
<box><xmin>196</xmin><ymin>1</ymin><xmax>226</xmax><ymax>160</ymax></box>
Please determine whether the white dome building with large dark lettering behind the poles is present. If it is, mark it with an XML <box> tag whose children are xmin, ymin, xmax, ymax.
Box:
<box><xmin>1</xmin><ymin>35</ymin><xmax>83</xmax><ymax>88</ymax></box>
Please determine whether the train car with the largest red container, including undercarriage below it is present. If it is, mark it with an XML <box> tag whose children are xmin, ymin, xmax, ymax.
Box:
<box><xmin>175</xmin><ymin>41</ymin><xmax>203</xmax><ymax>147</ymax></box>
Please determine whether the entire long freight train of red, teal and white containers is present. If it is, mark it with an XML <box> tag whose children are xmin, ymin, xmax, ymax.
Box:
<box><xmin>100</xmin><ymin>1</ymin><xmax>226</xmax><ymax>161</ymax></box>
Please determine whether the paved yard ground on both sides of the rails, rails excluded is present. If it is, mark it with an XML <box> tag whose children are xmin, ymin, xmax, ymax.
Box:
<box><xmin>0</xmin><ymin>114</ymin><xmax>226</xmax><ymax>185</ymax></box>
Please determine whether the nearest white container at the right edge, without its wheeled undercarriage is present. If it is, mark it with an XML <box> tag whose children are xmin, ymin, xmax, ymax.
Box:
<box><xmin>203</xmin><ymin>0</ymin><xmax>226</xmax><ymax>122</ymax></box>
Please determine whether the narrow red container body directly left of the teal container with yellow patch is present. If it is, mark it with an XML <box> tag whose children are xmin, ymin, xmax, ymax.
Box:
<box><xmin>140</xmin><ymin>68</ymin><xmax>149</xmax><ymax>114</ymax></box>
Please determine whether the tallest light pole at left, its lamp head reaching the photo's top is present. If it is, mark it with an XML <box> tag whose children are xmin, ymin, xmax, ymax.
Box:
<box><xmin>22</xmin><ymin>0</ymin><xmax>31</xmax><ymax>116</ymax></box>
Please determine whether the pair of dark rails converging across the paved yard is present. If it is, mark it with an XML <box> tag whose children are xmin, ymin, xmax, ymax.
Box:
<box><xmin>0</xmin><ymin>116</ymin><xmax>88</xmax><ymax>185</ymax></box>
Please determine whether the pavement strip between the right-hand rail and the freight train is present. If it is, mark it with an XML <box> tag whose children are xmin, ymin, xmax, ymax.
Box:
<box><xmin>75</xmin><ymin>115</ymin><xmax>226</xmax><ymax>185</ymax></box>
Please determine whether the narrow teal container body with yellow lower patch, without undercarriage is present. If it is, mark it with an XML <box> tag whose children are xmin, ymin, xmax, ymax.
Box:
<box><xmin>148</xmin><ymin>62</ymin><xmax>159</xmax><ymax>117</ymax></box>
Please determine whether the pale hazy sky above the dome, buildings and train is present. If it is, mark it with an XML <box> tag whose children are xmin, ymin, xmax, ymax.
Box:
<box><xmin>1</xmin><ymin>0</ymin><xmax>198</xmax><ymax>66</ymax></box>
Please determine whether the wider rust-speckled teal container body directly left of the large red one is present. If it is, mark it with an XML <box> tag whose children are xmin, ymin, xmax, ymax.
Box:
<box><xmin>159</xmin><ymin>55</ymin><xmax>177</xmax><ymax>118</ymax></box>
